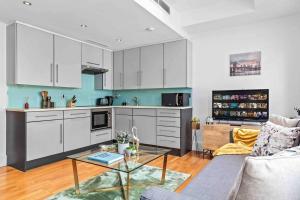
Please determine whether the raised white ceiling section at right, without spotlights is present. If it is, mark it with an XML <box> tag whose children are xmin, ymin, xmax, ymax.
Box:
<box><xmin>165</xmin><ymin>0</ymin><xmax>300</xmax><ymax>37</ymax></box>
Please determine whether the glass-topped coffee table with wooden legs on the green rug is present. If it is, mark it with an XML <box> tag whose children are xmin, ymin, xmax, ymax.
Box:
<box><xmin>68</xmin><ymin>145</ymin><xmax>171</xmax><ymax>200</ymax></box>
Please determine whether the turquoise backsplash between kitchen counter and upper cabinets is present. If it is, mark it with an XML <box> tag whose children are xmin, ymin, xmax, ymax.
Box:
<box><xmin>7</xmin><ymin>74</ymin><xmax>192</xmax><ymax>108</ymax></box>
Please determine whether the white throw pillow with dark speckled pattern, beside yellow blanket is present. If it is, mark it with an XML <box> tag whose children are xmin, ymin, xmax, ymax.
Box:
<box><xmin>251</xmin><ymin>122</ymin><xmax>300</xmax><ymax>156</ymax></box>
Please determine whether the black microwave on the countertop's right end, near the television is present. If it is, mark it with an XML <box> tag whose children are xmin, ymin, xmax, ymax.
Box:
<box><xmin>161</xmin><ymin>93</ymin><xmax>191</xmax><ymax>107</ymax></box>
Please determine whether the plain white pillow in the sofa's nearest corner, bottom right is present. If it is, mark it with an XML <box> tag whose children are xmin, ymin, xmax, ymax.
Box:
<box><xmin>236</xmin><ymin>156</ymin><xmax>300</xmax><ymax>200</ymax></box>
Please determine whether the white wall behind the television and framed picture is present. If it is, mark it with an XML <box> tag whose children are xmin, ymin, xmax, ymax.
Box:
<box><xmin>193</xmin><ymin>15</ymin><xmax>300</xmax><ymax>122</ymax></box>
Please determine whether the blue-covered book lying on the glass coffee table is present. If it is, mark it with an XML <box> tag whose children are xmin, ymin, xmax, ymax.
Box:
<box><xmin>88</xmin><ymin>152</ymin><xmax>124</xmax><ymax>165</ymax></box>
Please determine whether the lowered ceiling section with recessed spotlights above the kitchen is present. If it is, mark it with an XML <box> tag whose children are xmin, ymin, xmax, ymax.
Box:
<box><xmin>0</xmin><ymin>0</ymin><xmax>181</xmax><ymax>50</ymax></box>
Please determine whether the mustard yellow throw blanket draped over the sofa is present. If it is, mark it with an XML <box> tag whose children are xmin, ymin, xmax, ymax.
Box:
<box><xmin>213</xmin><ymin>128</ymin><xmax>260</xmax><ymax>156</ymax></box>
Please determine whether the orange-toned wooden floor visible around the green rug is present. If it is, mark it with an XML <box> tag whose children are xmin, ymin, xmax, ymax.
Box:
<box><xmin>0</xmin><ymin>152</ymin><xmax>209</xmax><ymax>200</ymax></box>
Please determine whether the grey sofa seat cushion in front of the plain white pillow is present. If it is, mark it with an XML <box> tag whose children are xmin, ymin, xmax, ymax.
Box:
<box><xmin>182</xmin><ymin>155</ymin><xmax>247</xmax><ymax>200</ymax></box>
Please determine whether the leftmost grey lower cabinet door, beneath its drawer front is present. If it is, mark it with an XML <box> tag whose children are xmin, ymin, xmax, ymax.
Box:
<box><xmin>26</xmin><ymin>120</ymin><xmax>63</xmax><ymax>161</ymax></box>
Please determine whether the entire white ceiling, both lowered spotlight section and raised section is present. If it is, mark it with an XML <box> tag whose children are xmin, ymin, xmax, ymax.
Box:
<box><xmin>0</xmin><ymin>0</ymin><xmax>300</xmax><ymax>50</ymax></box>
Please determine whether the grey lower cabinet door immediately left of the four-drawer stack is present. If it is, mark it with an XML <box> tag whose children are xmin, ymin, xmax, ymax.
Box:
<box><xmin>133</xmin><ymin>116</ymin><xmax>156</xmax><ymax>145</ymax></box>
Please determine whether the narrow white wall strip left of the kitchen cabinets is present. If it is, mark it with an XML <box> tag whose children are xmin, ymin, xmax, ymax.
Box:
<box><xmin>0</xmin><ymin>22</ymin><xmax>7</xmax><ymax>167</ymax></box>
